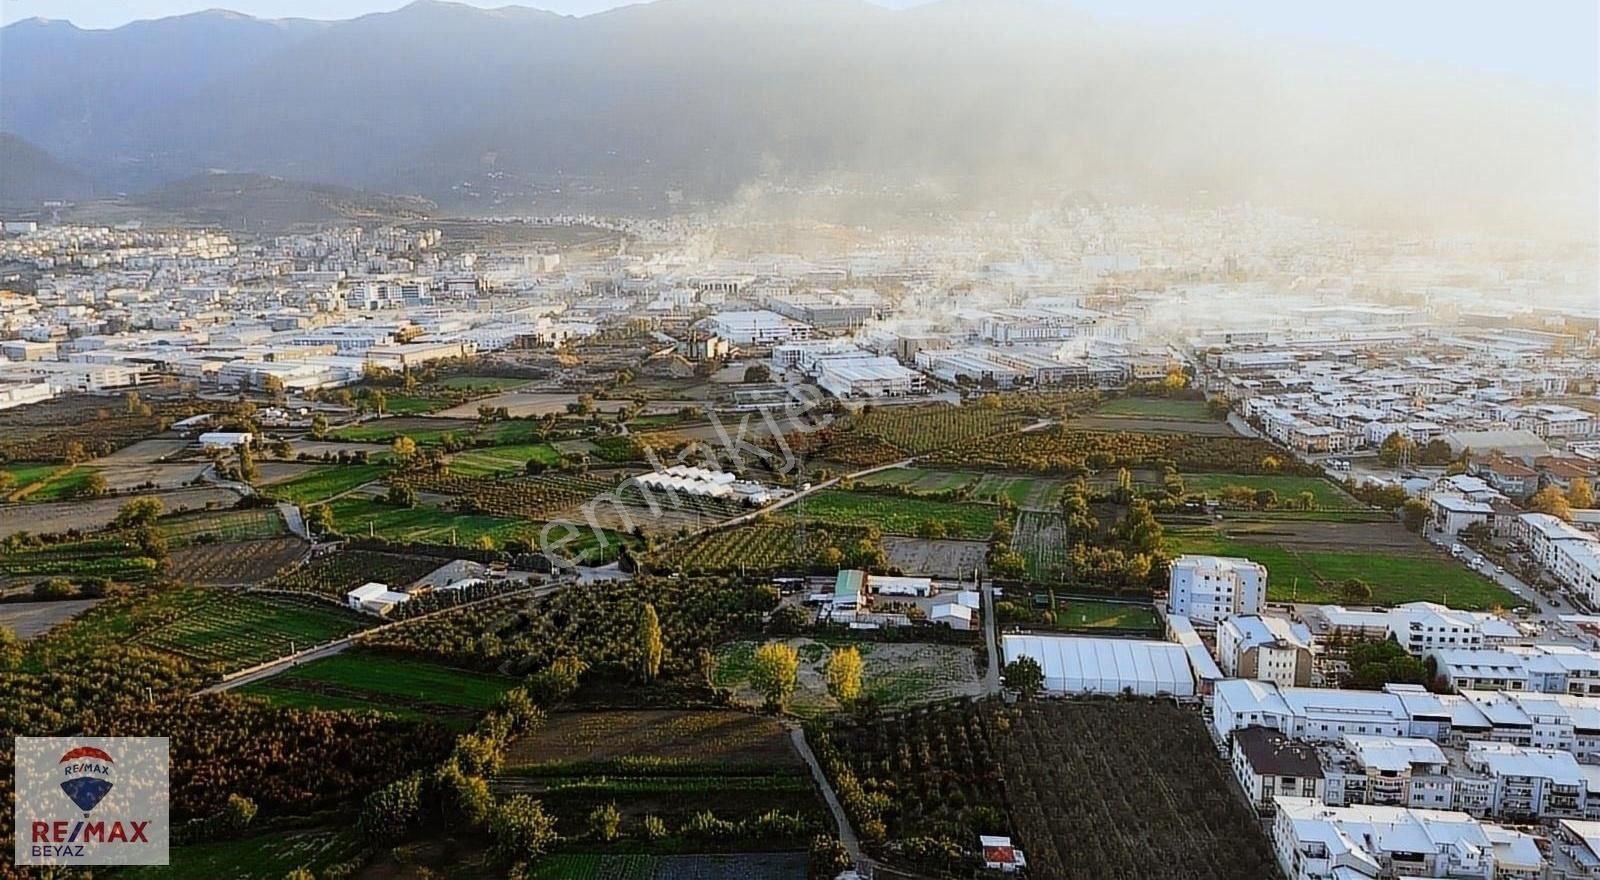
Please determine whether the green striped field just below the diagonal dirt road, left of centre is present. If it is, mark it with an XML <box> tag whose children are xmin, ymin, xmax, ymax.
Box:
<box><xmin>240</xmin><ymin>651</ymin><xmax>518</xmax><ymax>730</ymax></box>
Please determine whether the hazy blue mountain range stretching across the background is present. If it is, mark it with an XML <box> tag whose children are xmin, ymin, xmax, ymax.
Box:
<box><xmin>0</xmin><ymin>0</ymin><xmax>1595</xmax><ymax>234</ymax></box>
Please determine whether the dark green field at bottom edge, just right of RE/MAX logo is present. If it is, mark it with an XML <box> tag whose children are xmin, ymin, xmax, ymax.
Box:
<box><xmin>117</xmin><ymin>829</ymin><xmax>365</xmax><ymax>880</ymax></box>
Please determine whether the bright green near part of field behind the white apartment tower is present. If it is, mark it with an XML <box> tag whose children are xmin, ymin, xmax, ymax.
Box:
<box><xmin>1166</xmin><ymin>530</ymin><xmax>1520</xmax><ymax>611</ymax></box>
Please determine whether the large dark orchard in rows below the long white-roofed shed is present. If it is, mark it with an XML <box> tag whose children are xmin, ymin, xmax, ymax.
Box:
<box><xmin>808</xmin><ymin>701</ymin><xmax>1277</xmax><ymax>880</ymax></box>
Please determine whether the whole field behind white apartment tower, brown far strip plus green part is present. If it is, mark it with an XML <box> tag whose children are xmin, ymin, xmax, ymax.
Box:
<box><xmin>1166</xmin><ymin>522</ymin><xmax>1520</xmax><ymax>611</ymax></box>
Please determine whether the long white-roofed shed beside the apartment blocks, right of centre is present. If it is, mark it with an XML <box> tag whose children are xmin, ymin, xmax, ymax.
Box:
<box><xmin>1000</xmin><ymin>635</ymin><xmax>1195</xmax><ymax>696</ymax></box>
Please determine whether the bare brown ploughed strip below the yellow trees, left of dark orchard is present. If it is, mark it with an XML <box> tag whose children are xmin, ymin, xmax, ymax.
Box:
<box><xmin>506</xmin><ymin>709</ymin><xmax>800</xmax><ymax>773</ymax></box>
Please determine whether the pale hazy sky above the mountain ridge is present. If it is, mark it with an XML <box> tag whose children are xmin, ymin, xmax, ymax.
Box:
<box><xmin>0</xmin><ymin>0</ymin><xmax>1600</xmax><ymax>94</ymax></box>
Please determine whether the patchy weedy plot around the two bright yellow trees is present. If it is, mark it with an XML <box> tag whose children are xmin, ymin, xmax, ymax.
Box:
<box><xmin>712</xmin><ymin>638</ymin><xmax>984</xmax><ymax>718</ymax></box>
